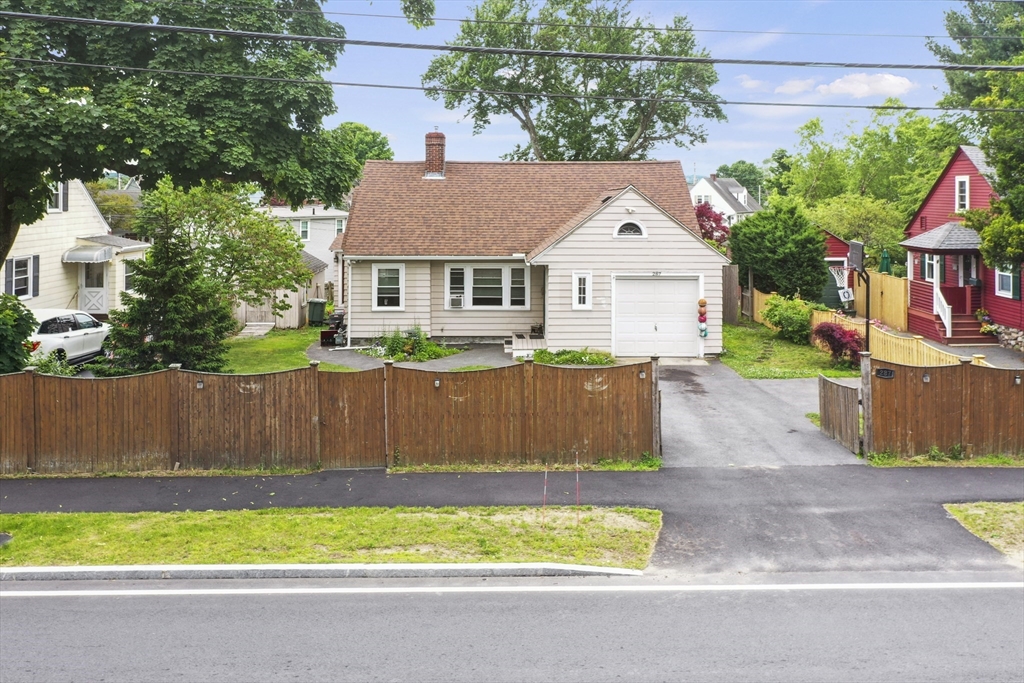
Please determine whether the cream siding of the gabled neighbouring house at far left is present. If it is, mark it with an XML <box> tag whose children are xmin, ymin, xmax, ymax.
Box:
<box><xmin>0</xmin><ymin>180</ymin><xmax>110</xmax><ymax>309</ymax></box>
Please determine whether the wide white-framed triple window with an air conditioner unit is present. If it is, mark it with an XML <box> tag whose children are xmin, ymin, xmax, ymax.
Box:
<box><xmin>444</xmin><ymin>264</ymin><xmax>529</xmax><ymax>309</ymax></box>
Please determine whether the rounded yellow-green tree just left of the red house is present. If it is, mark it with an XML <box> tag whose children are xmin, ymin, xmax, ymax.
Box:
<box><xmin>807</xmin><ymin>193</ymin><xmax>906</xmax><ymax>266</ymax></box>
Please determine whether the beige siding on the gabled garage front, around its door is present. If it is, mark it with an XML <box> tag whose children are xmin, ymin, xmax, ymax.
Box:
<box><xmin>534</xmin><ymin>191</ymin><xmax>727</xmax><ymax>354</ymax></box>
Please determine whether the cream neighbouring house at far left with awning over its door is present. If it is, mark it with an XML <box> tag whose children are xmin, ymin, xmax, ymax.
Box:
<box><xmin>0</xmin><ymin>180</ymin><xmax>150</xmax><ymax>318</ymax></box>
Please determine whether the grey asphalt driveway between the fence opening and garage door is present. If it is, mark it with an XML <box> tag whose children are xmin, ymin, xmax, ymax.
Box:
<box><xmin>660</xmin><ymin>360</ymin><xmax>861</xmax><ymax>467</ymax></box>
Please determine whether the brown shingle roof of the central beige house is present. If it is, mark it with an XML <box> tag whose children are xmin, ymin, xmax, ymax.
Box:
<box><xmin>331</xmin><ymin>161</ymin><xmax>696</xmax><ymax>256</ymax></box>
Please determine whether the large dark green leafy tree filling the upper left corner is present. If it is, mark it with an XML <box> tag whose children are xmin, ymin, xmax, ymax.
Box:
<box><xmin>0</xmin><ymin>0</ymin><xmax>434</xmax><ymax>259</ymax></box>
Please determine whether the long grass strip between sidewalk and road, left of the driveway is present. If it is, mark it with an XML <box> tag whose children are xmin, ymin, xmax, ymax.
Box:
<box><xmin>0</xmin><ymin>506</ymin><xmax>662</xmax><ymax>569</ymax></box>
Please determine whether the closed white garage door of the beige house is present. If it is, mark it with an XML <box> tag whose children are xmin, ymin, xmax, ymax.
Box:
<box><xmin>615</xmin><ymin>278</ymin><xmax>699</xmax><ymax>357</ymax></box>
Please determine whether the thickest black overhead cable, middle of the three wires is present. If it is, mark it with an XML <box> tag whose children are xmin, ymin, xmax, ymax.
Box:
<box><xmin>6</xmin><ymin>11</ymin><xmax>1024</xmax><ymax>73</ymax></box>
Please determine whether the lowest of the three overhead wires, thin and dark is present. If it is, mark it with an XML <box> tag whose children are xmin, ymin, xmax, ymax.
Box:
<box><xmin>8</xmin><ymin>55</ymin><xmax>1024</xmax><ymax>114</ymax></box>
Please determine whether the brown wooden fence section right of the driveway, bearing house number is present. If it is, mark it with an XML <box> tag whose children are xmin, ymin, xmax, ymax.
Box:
<box><xmin>863</xmin><ymin>357</ymin><xmax>1024</xmax><ymax>457</ymax></box>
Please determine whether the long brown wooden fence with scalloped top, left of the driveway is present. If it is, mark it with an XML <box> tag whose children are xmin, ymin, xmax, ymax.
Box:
<box><xmin>0</xmin><ymin>360</ymin><xmax>660</xmax><ymax>473</ymax></box>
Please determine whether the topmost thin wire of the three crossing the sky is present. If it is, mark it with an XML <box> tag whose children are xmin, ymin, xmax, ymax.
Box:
<box><xmin>142</xmin><ymin>0</ymin><xmax>1021</xmax><ymax>40</ymax></box>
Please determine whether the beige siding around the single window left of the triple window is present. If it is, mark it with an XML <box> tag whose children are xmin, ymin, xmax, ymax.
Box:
<box><xmin>345</xmin><ymin>260</ymin><xmax>431</xmax><ymax>339</ymax></box>
